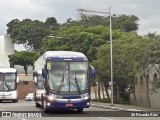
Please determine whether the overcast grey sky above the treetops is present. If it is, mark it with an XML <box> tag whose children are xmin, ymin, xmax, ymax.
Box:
<box><xmin>0</xmin><ymin>0</ymin><xmax>160</xmax><ymax>35</ymax></box>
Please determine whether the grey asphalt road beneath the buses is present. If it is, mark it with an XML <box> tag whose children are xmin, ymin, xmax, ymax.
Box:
<box><xmin>0</xmin><ymin>100</ymin><xmax>160</xmax><ymax>120</ymax></box>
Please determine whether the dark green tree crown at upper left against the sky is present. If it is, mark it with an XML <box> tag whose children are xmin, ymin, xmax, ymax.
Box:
<box><xmin>7</xmin><ymin>19</ymin><xmax>50</xmax><ymax>51</ymax></box>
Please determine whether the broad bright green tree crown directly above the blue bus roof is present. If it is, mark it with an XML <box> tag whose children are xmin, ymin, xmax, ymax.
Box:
<box><xmin>43</xmin><ymin>25</ymin><xmax>121</xmax><ymax>61</ymax></box>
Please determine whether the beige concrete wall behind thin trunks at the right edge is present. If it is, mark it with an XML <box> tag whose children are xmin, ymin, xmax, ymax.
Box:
<box><xmin>130</xmin><ymin>65</ymin><xmax>160</xmax><ymax>108</ymax></box>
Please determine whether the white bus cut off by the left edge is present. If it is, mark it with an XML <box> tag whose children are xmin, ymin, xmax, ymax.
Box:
<box><xmin>0</xmin><ymin>68</ymin><xmax>19</xmax><ymax>102</ymax></box>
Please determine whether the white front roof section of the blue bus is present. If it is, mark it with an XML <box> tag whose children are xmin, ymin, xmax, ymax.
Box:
<box><xmin>43</xmin><ymin>51</ymin><xmax>88</xmax><ymax>61</ymax></box>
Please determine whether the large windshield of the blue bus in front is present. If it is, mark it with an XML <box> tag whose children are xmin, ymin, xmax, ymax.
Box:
<box><xmin>47</xmin><ymin>61</ymin><xmax>88</xmax><ymax>92</ymax></box>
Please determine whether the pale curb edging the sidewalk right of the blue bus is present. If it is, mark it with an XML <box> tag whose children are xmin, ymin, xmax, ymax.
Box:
<box><xmin>91</xmin><ymin>104</ymin><xmax>142</xmax><ymax>111</ymax></box>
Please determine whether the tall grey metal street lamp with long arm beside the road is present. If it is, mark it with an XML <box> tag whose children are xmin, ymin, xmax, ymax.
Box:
<box><xmin>77</xmin><ymin>7</ymin><xmax>113</xmax><ymax>106</ymax></box>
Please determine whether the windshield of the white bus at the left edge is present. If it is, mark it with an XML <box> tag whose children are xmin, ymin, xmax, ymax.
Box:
<box><xmin>0</xmin><ymin>73</ymin><xmax>16</xmax><ymax>91</ymax></box>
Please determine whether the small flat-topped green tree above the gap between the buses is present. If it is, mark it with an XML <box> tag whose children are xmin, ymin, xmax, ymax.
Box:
<box><xmin>12</xmin><ymin>51</ymin><xmax>39</xmax><ymax>75</ymax></box>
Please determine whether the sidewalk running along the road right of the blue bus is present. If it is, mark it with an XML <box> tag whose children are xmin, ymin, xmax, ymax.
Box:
<box><xmin>91</xmin><ymin>101</ymin><xmax>160</xmax><ymax>111</ymax></box>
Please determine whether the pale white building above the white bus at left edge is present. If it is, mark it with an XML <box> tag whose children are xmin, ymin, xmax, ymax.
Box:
<box><xmin>0</xmin><ymin>35</ymin><xmax>14</xmax><ymax>67</ymax></box>
